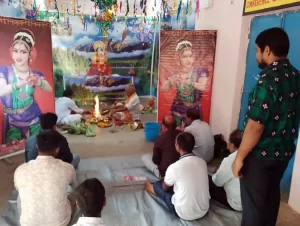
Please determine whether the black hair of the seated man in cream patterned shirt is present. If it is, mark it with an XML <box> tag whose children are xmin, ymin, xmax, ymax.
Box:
<box><xmin>36</xmin><ymin>130</ymin><xmax>62</xmax><ymax>153</ymax></box>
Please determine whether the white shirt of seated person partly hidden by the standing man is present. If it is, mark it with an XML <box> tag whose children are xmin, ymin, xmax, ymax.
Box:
<box><xmin>212</xmin><ymin>151</ymin><xmax>243</xmax><ymax>211</ymax></box>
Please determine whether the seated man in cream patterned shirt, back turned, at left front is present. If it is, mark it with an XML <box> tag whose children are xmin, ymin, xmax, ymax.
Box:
<box><xmin>14</xmin><ymin>131</ymin><xmax>76</xmax><ymax>226</ymax></box>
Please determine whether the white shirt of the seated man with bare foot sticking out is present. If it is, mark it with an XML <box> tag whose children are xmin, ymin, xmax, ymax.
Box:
<box><xmin>164</xmin><ymin>154</ymin><xmax>210</xmax><ymax>220</ymax></box>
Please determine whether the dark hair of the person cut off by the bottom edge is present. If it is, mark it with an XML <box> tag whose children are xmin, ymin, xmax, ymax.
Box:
<box><xmin>75</xmin><ymin>178</ymin><xmax>105</xmax><ymax>217</ymax></box>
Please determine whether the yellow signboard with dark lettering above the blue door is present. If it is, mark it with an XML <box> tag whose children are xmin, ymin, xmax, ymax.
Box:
<box><xmin>243</xmin><ymin>0</ymin><xmax>300</xmax><ymax>15</ymax></box>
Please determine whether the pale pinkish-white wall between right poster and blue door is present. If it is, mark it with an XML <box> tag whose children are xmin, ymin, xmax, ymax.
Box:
<box><xmin>196</xmin><ymin>0</ymin><xmax>250</xmax><ymax>138</ymax></box>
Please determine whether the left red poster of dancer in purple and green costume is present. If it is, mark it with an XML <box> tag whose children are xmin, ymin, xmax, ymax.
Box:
<box><xmin>0</xmin><ymin>17</ymin><xmax>54</xmax><ymax>150</ymax></box>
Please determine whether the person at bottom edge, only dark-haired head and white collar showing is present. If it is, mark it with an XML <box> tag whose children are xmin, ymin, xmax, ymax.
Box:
<box><xmin>74</xmin><ymin>178</ymin><xmax>106</xmax><ymax>226</ymax></box>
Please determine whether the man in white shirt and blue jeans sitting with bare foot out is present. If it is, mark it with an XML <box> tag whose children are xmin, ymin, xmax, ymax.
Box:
<box><xmin>145</xmin><ymin>132</ymin><xmax>210</xmax><ymax>220</ymax></box>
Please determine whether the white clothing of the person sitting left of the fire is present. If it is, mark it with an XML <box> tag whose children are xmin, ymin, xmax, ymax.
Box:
<box><xmin>55</xmin><ymin>97</ymin><xmax>84</xmax><ymax>125</ymax></box>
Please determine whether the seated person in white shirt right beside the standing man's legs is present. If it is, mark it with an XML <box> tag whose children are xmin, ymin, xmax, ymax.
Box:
<box><xmin>209</xmin><ymin>130</ymin><xmax>242</xmax><ymax>211</ymax></box>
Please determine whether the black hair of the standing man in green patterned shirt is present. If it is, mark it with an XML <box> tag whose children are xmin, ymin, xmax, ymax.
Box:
<box><xmin>255</xmin><ymin>27</ymin><xmax>290</xmax><ymax>57</ymax></box>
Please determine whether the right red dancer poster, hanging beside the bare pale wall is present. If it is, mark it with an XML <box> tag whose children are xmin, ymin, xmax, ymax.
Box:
<box><xmin>158</xmin><ymin>31</ymin><xmax>216</xmax><ymax>127</ymax></box>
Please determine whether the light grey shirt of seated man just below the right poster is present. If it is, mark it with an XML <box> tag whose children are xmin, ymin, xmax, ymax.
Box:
<box><xmin>184</xmin><ymin>119</ymin><xmax>215</xmax><ymax>163</ymax></box>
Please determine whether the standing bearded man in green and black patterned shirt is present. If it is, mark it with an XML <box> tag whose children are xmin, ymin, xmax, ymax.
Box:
<box><xmin>232</xmin><ymin>28</ymin><xmax>300</xmax><ymax>226</ymax></box>
